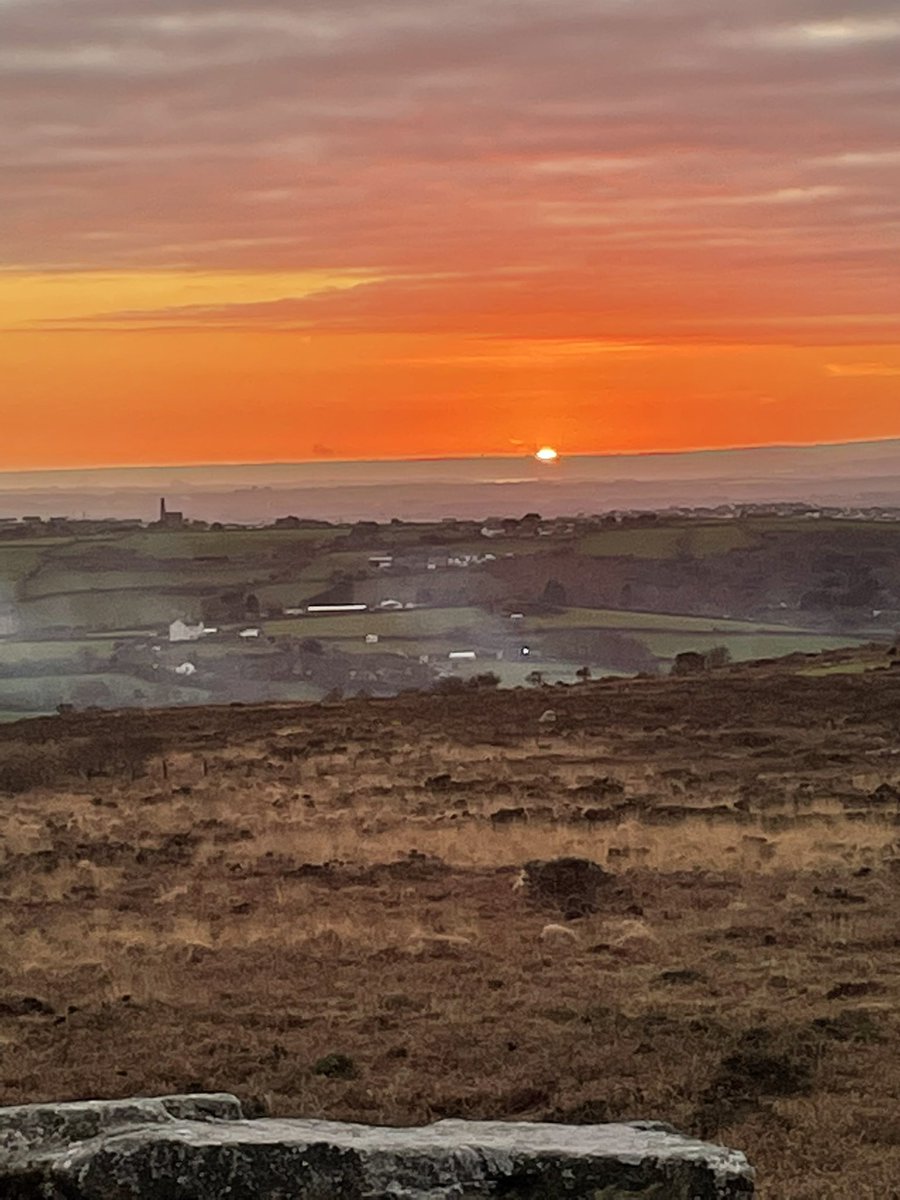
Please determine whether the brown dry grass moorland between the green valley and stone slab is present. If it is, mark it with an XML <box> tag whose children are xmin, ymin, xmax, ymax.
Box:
<box><xmin>0</xmin><ymin>670</ymin><xmax>900</xmax><ymax>1200</ymax></box>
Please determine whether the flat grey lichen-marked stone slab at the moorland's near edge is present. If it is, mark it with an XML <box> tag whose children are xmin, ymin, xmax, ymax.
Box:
<box><xmin>0</xmin><ymin>1094</ymin><xmax>754</xmax><ymax>1200</ymax></box>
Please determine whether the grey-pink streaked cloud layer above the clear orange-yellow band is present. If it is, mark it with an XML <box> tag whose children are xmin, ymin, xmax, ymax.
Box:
<box><xmin>0</xmin><ymin>0</ymin><xmax>900</xmax><ymax>342</ymax></box>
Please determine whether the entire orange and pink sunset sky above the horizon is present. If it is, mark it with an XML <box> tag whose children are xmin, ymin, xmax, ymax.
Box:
<box><xmin>0</xmin><ymin>0</ymin><xmax>900</xmax><ymax>469</ymax></box>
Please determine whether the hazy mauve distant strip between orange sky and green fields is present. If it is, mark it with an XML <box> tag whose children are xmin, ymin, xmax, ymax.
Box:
<box><xmin>0</xmin><ymin>438</ymin><xmax>900</xmax><ymax>523</ymax></box>
